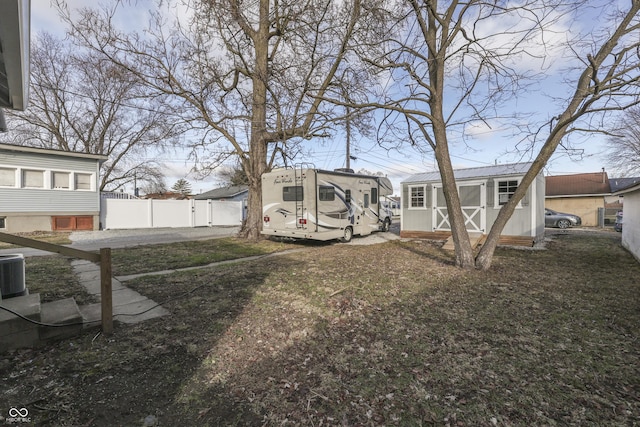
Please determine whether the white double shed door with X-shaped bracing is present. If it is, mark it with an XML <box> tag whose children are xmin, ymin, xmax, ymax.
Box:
<box><xmin>432</xmin><ymin>181</ymin><xmax>487</xmax><ymax>233</ymax></box>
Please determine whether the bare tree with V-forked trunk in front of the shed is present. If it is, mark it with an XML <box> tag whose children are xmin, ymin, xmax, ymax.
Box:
<box><xmin>361</xmin><ymin>0</ymin><xmax>640</xmax><ymax>269</ymax></box>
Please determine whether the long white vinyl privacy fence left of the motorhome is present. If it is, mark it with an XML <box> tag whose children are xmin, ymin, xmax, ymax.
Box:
<box><xmin>100</xmin><ymin>198</ymin><xmax>243</xmax><ymax>230</ymax></box>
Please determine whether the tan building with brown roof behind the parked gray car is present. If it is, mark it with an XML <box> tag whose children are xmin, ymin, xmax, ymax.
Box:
<box><xmin>545</xmin><ymin>170</ymin><xmax>611</xmax><ymax>227</ymax></box>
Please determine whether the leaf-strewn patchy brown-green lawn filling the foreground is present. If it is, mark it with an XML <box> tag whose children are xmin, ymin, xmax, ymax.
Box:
<box><xmin>0</xmin><ymin>230</ymin><xmax>640</xmax><ymax>426</ymax></box>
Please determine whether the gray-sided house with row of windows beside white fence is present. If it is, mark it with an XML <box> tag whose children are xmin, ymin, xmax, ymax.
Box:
<box><xmin>0</xmin><ymin>144</ymin><xmax>107</xmax><ymax>233</ymax></box>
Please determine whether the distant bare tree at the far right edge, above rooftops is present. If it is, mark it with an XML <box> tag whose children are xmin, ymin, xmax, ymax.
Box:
<box><xmin>605</xmin><ymin>107</ymin><xmax>640</xmax><ymax>177</ymax></box>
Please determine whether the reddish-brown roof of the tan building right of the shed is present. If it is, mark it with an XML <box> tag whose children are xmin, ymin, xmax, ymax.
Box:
<box><xmin>545</xmin><ymin>171</ymin><xmax>611</xmax><ymax>197</ymax></box>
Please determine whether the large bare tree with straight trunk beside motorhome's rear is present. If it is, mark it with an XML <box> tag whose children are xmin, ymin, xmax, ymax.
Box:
<box><xmin>56</xmin><ymin>0</ymin><xmax>376</xmax><ymax>239</ymax></box>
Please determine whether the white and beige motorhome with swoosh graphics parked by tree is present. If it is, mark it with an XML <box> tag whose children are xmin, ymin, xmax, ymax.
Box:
<box><xmin>262</xmin><ymin>166</ymin><xmax>393</xmax><ymax>242</ymax></box>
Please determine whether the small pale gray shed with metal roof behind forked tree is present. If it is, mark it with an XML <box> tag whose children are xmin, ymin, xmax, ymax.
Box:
<box><xmin>400</xmin><ymin>163</ymin><xmax>545</xmax><ymax>245</ymax></box>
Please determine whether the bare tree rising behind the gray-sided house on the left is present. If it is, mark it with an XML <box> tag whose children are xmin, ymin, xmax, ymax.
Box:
<box><xmin>3</xmin><ymin>33</ymin><xmax>179</xmax><ymax>190</ymax></box>
